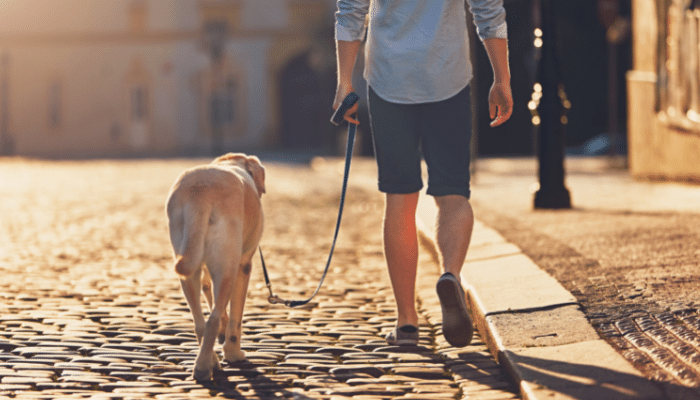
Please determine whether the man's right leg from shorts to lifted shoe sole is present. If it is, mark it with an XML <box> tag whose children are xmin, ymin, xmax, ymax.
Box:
<box><xmin>412</xmin><ymin>87</ymin><xmax>474</xmax><ymax>347</ymax></box>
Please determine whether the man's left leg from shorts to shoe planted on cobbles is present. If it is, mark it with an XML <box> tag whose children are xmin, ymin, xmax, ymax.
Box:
<box><xmin>368</xmin><ymin>87</ymin><xmax>423</xmax><ymax>338</ymax></box>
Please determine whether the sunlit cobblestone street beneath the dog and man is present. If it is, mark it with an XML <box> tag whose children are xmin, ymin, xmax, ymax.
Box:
<box><xmin>0</xmin><ymin>158</ymin><xmax>517</xmax><ymax>400</ymax></box>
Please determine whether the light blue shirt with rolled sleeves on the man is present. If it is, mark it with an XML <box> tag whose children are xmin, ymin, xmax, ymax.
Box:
<box><xmin>335</xmin><ymin>0</ymin><xmax>508</xmax><ymax>104</ymax></box>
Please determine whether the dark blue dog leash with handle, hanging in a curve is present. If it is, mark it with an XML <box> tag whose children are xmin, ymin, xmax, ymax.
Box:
<box><xmin>258</xmin><ymin>93</ymin><xmax>360</xmax><ymax>308</ymax></box>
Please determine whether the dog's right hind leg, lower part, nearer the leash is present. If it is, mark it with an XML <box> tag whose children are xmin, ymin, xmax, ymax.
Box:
<box><xmin>224</xmin><ymin>261</ymin><xmax>251</xmax><ymax>362</ymax></box>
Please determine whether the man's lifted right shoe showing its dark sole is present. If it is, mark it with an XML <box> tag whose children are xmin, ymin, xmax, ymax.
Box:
<box><xmin>437</xmin><ymin>272</ymin><xmax>474</xmax><ymax>347</ymax></box>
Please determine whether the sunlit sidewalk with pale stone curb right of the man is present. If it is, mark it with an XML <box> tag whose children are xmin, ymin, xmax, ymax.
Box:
<box><xmin>412</xmin><ymin>158</ymin><xmax>700</xmax><ymax>399</ymax></box>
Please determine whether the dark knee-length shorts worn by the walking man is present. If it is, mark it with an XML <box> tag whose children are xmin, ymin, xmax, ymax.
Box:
<box><xmin>368</xmin><ymin>86</ymin><xmax>472</xmax><ymax>198</ymax></box>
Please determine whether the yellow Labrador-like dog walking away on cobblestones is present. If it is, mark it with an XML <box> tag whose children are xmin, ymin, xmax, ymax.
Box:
<box><xmin>166</xmin><ymin>153</ymin><xmax>265</xmax><ymax>380</ymax></box>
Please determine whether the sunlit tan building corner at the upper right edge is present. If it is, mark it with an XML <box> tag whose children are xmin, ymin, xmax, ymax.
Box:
<box><xmin>627</xmin><ymin>0</ymin><xmax>700</xmax><ymax>182</ymax></box>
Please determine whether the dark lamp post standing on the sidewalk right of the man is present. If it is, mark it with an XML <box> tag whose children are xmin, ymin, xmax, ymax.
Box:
<box><xmin>533</xmin><ymin>0</ymin><xmax>571</xmax><ymax>209</ymax></box>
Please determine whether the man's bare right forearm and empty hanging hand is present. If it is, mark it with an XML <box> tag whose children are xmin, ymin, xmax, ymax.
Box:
<box><xmin>483</xmin><ymin>38</ymin><xmax>513</xmax><ymax>127</ymax></box>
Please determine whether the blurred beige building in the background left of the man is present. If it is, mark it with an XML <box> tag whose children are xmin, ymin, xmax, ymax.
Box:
<box><xmin>0</xmin><ymin>0</ymin><xmax>334</xmax><ymax>157</ymax></box>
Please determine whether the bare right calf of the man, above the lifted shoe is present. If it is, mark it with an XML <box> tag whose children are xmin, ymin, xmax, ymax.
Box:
<box><xmin>435</xmin><ymin>195</ymin><xmax>474</xmax><ymax>281</ymax></box>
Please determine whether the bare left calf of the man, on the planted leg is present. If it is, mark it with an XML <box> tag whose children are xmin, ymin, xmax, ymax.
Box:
<box><xmin>384</xmin><ymin>193</ymin><xmax>418</xmax><ymax>327</ymax></box>
